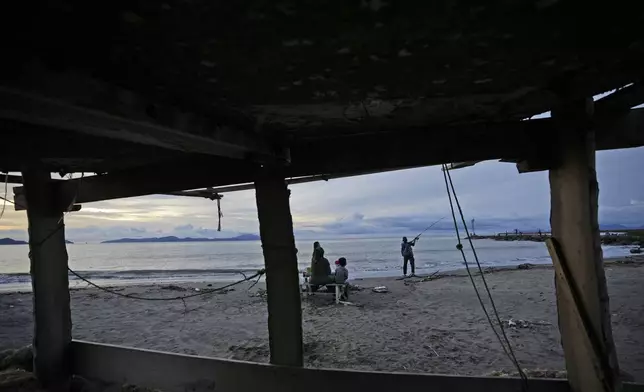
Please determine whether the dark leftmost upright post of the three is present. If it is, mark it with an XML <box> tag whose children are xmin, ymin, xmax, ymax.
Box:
<box><xmin>22</xmin><ymin>169</ymin><xmax>72</xmax><ymax>391</ymax></box>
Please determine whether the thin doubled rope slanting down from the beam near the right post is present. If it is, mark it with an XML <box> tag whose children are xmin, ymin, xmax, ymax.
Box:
<box><xmin>442</xmin><ymin>165</ymin><xmax>528</xmax><ymax>391</ymax></box>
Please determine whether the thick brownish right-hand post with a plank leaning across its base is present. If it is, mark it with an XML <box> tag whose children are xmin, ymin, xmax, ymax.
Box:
<box><xmin>550</xmin><ymin>100</ymin><xmax>619</xmax><ymax>392</ymax></box>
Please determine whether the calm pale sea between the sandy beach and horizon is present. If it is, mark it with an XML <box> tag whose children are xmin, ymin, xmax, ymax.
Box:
<box><xmin>0</xmin><ymin>235</ymin><xmax>629</xmax><ymax>291</ymax></box>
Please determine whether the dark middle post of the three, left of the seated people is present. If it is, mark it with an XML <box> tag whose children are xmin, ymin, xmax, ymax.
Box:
<box><xmin>255</xmin><ymin>169</ymin><xmax>303</xmax><ymax>366</ymax></box>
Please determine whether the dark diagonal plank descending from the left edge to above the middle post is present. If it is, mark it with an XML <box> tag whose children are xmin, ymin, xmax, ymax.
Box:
<box><xmin>0</xmin><ymin>86</ymin><xmax>275</xmax><ymax>159</ymax></box>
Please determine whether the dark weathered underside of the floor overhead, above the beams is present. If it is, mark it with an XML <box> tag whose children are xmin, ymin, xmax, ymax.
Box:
<box><xmin>5</xmin><ymin>0</ymin><xmax>644</xmax><ymax>136</ymax></box>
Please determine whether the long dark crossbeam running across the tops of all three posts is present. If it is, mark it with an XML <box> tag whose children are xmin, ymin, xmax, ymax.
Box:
<box><xmin>14</xmin><ymin>109</ymin><xmax>644</xmax><ymax>209</ymax></box>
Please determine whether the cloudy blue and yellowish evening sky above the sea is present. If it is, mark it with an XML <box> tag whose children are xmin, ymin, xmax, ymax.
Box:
<box><xmin>0</xmin><ymin>148</ymin><xmax>644</xmax><ymax>242</ymax></box>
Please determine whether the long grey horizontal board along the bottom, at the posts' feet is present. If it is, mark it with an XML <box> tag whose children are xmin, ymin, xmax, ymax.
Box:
<box><xmin>72</xmin><ymin>341</ymin><xmax>570</xmax><ymax>392</ymax></box>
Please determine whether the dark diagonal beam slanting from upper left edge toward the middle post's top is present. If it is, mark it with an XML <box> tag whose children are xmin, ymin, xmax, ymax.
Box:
<box><xmin>0</xmin><ymin>81</ymin><xmax>283</xmax><ymax>161</ymax></box>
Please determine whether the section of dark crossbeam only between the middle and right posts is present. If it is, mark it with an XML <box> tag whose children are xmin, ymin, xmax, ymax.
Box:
<box><xmin>289</xmin><ymin>119</ymin><xmax>554</xmax><ymax>176</ymax></box>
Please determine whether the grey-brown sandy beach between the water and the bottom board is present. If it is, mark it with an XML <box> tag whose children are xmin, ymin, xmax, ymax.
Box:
<box><xmin>0</xmin><ymin>263</ymin><xmax>644</xmax><ymax>382</ymax></box>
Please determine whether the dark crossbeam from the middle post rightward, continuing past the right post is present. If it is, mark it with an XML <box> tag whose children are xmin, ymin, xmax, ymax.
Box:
<box><xmin>289</xmin><ymin>109</ymin><xmax>644</xmax><ymax>176</ymax></box>
